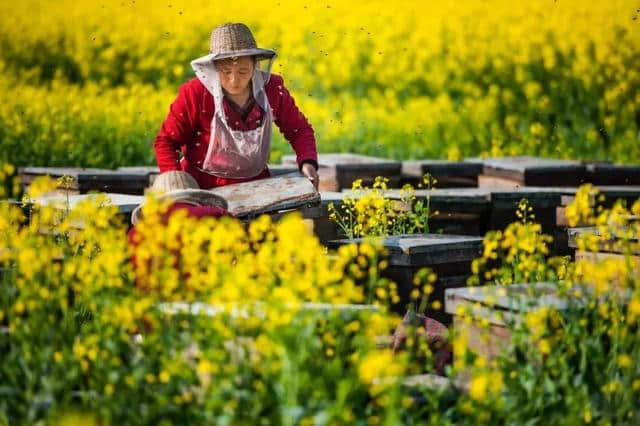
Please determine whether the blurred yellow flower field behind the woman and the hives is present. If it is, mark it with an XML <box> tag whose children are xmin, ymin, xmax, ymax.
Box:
<box><xmin>0</xmin><ymin>0</ymin><xmax>640</xmax><ymax>166</ymax></box>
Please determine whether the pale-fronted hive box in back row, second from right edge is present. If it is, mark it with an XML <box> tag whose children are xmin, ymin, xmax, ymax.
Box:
<box><xmin>472</xmin><ymin>156</ymin><xmax>586</xmax><ymax>188</ymax></box>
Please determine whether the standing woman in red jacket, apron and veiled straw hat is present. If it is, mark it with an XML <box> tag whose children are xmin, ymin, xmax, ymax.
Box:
<box><xmin>154</xmin><ymin>24</ymin><xmax>318</xmax><ymax>189</ymax></box>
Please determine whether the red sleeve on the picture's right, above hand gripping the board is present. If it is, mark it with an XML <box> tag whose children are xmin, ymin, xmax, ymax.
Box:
<box><xmin>268</xmin><ymin>75</ymin><xmax>318</xmax><ymax>169</ymax></box>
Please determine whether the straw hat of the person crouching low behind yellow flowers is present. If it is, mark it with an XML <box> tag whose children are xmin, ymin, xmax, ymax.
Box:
<box><xmin>131</xmin><ymin>170</ymin><xmax>227</xmax><ymax>225</ymax></box>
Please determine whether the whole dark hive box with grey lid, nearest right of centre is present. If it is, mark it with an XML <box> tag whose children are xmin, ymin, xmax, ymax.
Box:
<box><xmin>328</xmin><ymin>234</ymin><xmax>482</xmax><ymax>324</ymax></box>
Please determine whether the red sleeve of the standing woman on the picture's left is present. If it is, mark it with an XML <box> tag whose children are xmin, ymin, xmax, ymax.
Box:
<box><xmin>153</xmin><ymin>82</ymin><xmax>198</xmax><ymax>173</ymax></box>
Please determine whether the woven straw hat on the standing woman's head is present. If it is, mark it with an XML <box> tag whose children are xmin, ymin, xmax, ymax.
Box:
<box><xmin>209</xmin><ymin>23</ymin><xmax>276</xmax><ymax>61</ymax></box>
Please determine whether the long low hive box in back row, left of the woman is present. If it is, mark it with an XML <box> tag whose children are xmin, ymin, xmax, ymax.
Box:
<box><xmin>19</xmin><ymin>167</ymin><xmax>150</xmax><ymax>195</ymax></box>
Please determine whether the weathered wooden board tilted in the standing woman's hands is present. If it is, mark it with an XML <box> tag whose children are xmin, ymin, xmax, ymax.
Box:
<box><xmin>210</xmin><ymin>177</ymin><xmax>320</xmax><ymax>217</ymax></box>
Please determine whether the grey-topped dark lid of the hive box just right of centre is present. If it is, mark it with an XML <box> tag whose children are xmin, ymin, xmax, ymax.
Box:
<box><xmin>328</xmin><ymin>234</ymin><xmax>482</xmax><ymax>266</ymax></box>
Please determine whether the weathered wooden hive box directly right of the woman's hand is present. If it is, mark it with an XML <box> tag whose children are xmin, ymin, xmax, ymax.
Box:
<box><xmin>282</xmin><ymin>153</ymin><xmax>402</xmax><ymax>191</ymax></box>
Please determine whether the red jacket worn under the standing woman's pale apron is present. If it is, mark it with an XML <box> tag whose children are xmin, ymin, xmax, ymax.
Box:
<box><xmin>154</xmin><ymin>74</ymin><xmax>318</xmax><ymax>189</ymax></box>
